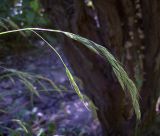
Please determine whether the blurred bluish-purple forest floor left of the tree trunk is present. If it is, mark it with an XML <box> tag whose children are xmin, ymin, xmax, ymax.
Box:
<box><xmin>0</xmin><ymin>42</ymin><xmax>101</xmax><ymax>136</ymax></box>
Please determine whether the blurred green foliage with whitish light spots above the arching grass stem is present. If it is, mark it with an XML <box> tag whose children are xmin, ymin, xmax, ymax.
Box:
<box><xmin>0</xmin><ymin>0</ymin><xmax>49</xmax><ymax>27</ymax></box>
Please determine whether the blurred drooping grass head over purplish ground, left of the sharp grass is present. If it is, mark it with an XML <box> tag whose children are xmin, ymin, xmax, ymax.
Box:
<box><xmin>0</xmin><ymin>66</ymin><xmax>61</xmax><ymax>102</ymax></box>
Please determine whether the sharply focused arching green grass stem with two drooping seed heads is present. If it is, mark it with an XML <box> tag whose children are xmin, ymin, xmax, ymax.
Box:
<box><xmin>0</xmin><ymin>28</ymin><xmax>141</xmax><ymax>119</ymax></box>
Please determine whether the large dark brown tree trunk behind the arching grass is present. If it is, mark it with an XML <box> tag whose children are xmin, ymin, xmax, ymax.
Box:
<box><xmin>41</xmin><ymin>0</ymin><xmax>160</xmax><ymax>136</ymax></box>
